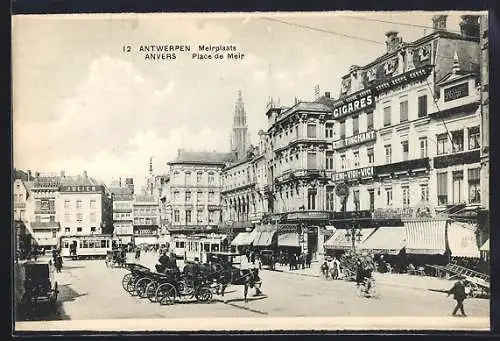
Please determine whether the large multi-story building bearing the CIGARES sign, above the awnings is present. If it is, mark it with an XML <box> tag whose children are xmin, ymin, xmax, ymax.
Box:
<box><xmin>324</xmin><ymin>15</ymin><xmax>480</xmax><ymax>255</ymax></box>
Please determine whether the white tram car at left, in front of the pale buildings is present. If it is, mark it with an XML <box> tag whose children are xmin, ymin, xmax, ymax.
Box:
<box><xmin>59</xmin><ymin>234</ymin><xmax>121</xmax><ymax>259</ymax></box>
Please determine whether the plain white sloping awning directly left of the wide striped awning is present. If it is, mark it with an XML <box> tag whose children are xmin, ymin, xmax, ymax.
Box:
<box><xmin>360</xmin><ymin>226</ymin><xmax>406</xmax><ymax>255</ymax></box>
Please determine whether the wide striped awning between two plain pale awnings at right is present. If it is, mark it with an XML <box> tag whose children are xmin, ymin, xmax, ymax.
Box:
<box><xmin>404</xmin><ymin>220</ymin><xmax>446</xmax><ymax>255</ymax></box>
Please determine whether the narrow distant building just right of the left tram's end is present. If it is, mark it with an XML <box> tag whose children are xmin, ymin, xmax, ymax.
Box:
<box><xmin>110</xmin><ymin>187</ymin><xmax>134</xmax><ymax>244</ymax></box>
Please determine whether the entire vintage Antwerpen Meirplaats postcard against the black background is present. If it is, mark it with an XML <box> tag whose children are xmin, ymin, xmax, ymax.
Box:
<box><xmin>12</xmin><ymin>12</ymin><xmax>490</xmax><ymax>333</ymax></box>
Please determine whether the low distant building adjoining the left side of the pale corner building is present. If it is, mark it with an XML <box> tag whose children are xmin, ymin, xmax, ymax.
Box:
<box><xmin>133</xmin><ymin>195</ymin><xmax>160</xmax><ymax>245</ymax></box>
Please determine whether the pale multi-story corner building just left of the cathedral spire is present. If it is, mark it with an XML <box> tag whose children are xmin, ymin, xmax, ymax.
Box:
<box><xmin>166</xmin><ymin>150</ymin><xmax>233</xmax><ymax>233</ymax></box>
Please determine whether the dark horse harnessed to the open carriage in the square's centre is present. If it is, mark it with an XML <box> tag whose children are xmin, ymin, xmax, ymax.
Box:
<box><xmin>217</xmin><ymin>266</ymin><xmax>262</xmax><ymax>303</ymax></box>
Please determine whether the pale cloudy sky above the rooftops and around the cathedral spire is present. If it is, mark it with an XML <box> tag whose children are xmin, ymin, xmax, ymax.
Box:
<box><xmin>12</xmin><ymin>12</ymin><xmax>480</xmax><ymax>190</ymax></box>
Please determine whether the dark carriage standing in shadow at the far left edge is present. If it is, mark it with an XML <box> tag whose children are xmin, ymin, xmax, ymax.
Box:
<box><xmin>21</xmin><ymin>261</ymin><xmax>59</xmax><ymax>304</ymax></box>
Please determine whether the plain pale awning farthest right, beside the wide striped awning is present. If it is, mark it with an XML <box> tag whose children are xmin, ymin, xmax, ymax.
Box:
<box><xmin>448</xmin><ymin>222</ymin><xmax>481</xmax><ymax>258</ymax></box>
